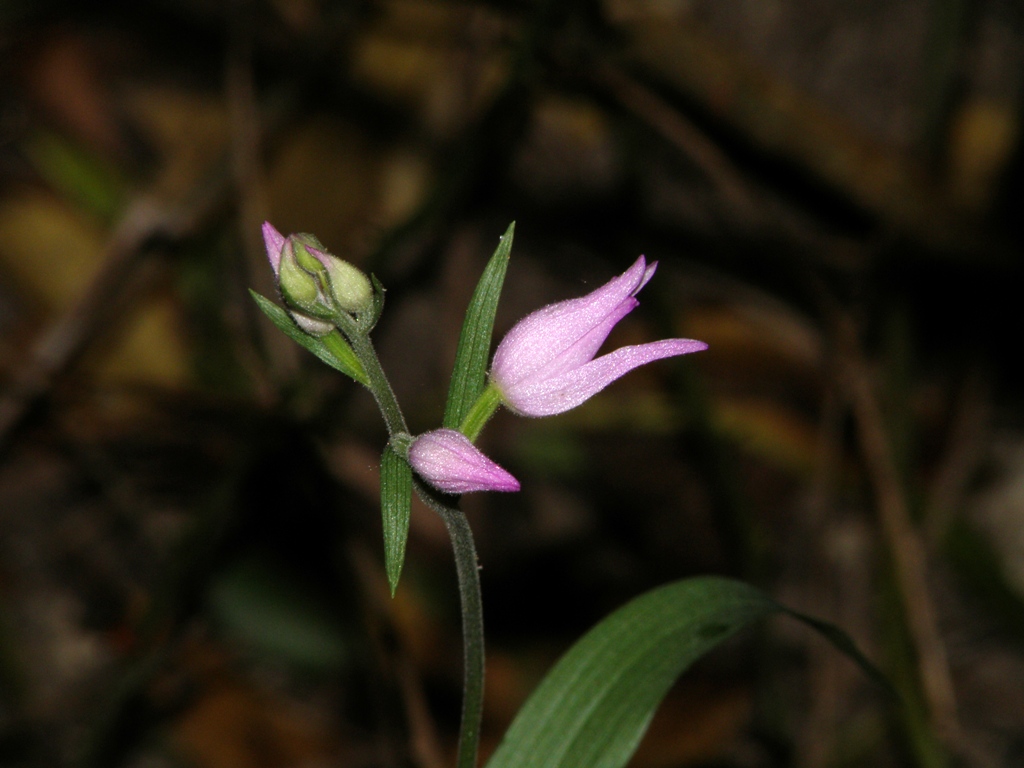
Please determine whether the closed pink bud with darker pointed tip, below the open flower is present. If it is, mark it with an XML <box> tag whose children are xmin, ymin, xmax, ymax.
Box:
<box><xmin>409</xmin><ymin>429</ymin><xmax>519</xmax><ymax>494</ymax></box>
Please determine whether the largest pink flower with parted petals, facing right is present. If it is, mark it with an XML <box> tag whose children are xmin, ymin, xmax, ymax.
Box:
<box><xmin>490</xmin><ymin>256</ymin><xmax>708</xmax><ymax>416</ymax></box>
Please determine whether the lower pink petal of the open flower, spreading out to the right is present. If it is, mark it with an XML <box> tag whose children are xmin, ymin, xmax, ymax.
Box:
<box><xmin>506</xmin><ymin>339</ymin><xmax>708</xmax><ymax>416</ymax></box>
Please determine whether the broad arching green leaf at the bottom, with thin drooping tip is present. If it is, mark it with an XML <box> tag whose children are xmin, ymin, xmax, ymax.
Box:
<box><xmin>487</xmin><ymin>577</ymin><xmax>881</xmax><ymax>768</ymax></box>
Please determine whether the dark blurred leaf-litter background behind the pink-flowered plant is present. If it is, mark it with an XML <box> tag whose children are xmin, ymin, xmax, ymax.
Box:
<box><xmin>0</xmin><ymin>0</ymin><xmax>1024</xmax><ymax>768</ymax></box>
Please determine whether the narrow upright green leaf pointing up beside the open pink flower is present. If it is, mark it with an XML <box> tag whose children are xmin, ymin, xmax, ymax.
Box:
<box><xmin>444</xmin><ymin>221</ymin><xmax>515</xmax><ymax>429</ymax></box>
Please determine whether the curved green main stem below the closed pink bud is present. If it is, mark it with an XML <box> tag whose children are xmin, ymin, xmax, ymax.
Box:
<box><xmin>415</xmin><ymin>478</ymin><xmax>483</xmax><ymax>768</ymax></box>
